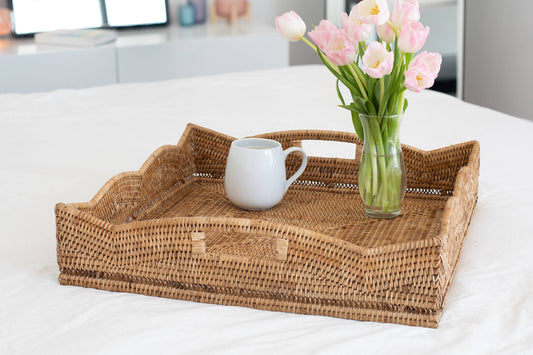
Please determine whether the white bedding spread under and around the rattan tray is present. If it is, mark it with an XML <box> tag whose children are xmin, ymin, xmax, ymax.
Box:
<box><xmin>0</xmin><ymin>66</ymin><xmax>533</xmax><ymax>354</ymax></box>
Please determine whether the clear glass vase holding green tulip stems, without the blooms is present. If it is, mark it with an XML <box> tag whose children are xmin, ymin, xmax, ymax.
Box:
<box><xmin>358</xmin><ymin>114</ymin><xmax>406</xmax><ymax>218</ymax></box>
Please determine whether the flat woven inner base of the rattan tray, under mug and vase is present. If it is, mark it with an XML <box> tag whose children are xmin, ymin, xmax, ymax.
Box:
<box><xmin>136</xmin><ymin>178</ymin><xmax>449</xmax><ymax>248</ymax></box>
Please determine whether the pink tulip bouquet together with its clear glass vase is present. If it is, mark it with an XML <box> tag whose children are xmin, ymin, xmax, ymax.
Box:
<box><xmin>276</xmin><ymin>0</ymin><xmax>442</xmax><ymax>218</ymax></box>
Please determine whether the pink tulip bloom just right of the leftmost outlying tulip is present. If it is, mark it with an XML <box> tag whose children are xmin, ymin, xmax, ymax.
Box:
<box><xmin>309</xmin><ymin>20</ymin><xmax>357</xmax><ymax>65</ymax></box>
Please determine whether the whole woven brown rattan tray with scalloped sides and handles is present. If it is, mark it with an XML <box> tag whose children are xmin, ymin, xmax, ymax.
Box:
<box><xmin>56</xmin><ymin>124</ymin><xmax>479</xmax><ymax>327</ymax></box>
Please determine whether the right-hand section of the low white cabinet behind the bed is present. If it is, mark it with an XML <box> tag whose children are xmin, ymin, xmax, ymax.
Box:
<box><xmin>116</xmin><ymin>24</ymin><xmax>289</xmax><ymax>83</ymax></box>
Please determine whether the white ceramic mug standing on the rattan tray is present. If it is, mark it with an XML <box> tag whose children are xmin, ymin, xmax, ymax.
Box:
<box><xmin>225</xmin><ymin>138</ymin><xmax>307</xmax><ymax>211</ymax></box>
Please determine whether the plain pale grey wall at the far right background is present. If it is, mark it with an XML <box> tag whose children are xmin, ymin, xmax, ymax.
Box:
<box><xmin>463</xmin><ymin>0</ymin><xmax>533</xmax><ymax>120</ymax></box>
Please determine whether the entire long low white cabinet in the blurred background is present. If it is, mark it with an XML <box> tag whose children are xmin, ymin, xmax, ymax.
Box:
<box><xmin>0</xmin><ymin>24</ymin><xmax>289</xmax><ymax>93</ymax></box>
